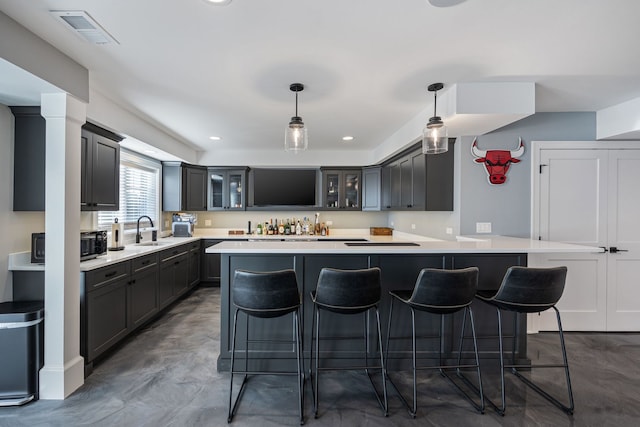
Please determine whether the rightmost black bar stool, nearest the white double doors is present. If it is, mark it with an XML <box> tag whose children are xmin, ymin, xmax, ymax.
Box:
<box><xmin>476</xmin><ymin>267</ymin><xmax>574</xmax><ymax>415</ymax></box>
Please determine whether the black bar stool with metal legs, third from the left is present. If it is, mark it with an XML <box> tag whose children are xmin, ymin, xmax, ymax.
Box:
<box><xmin>385</xmin><ymin>267</ymin><xmax>484</xmax><ymax>418</ymax></box>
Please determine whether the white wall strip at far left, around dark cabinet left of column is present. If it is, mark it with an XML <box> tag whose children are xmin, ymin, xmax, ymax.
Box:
<box><xmin>0</xmin><ymin>105</ymin><xmax>44</xmax><ymax>302</ymax></box>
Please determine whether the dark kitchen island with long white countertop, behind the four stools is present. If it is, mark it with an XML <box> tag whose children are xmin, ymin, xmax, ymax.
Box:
<box><xmin>205</xmin><ymin>233</ymin><xmax>602</xmax><ymax>371</ymax></box>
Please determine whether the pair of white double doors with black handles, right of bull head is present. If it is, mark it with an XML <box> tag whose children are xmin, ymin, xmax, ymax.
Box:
<box><xmin>530</xmin><ymin>143</ymin><xmax>640</xmax><ymax>331</ymax></box>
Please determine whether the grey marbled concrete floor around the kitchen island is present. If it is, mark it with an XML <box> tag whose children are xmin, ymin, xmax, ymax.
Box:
<box><xmin>0</xmin><ymin>288</ymin><xmax>640</xmax><ymax>427</ymax></box>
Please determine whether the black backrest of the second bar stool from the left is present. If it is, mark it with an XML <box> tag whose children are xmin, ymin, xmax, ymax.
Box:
<box><xmin>314</xmin><ymin>267</ymin><xmax>381</xmax><ymax>313</ymax></box>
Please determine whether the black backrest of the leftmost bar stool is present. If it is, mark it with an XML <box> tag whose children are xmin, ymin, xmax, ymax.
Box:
<box><xmin>232</xmin><ymin>270</ymin><xmax>300</xmax><ymax>317</ymax></box>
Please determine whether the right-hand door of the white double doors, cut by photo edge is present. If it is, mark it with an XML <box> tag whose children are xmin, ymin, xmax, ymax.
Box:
<box><xmin>607</xmin><ymin>150</ymin><xmax>640</xmax><ymax>331</ymax></box>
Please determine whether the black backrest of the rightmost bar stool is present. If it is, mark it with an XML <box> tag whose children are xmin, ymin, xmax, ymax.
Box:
<box><xmin>492</xmin><ymin>267</ymin><xmax>567</xmax><ymax>313</ymax></box>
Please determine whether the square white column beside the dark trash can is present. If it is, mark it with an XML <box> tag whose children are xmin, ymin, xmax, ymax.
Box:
<box><xmin>40</xmin><ymin>93</ymin><xmax>86</xmax><ymax>399</ymax></box>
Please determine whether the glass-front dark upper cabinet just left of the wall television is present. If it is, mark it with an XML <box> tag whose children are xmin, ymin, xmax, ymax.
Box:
<box><xmin>207</xmin><ymin>168</ymin><xmax>247</xmax><ymax>211</ymax></box>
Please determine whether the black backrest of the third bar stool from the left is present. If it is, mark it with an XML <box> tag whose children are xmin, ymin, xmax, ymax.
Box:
<box><xmin>407</xmin><ymin>267</ymin><xmax>479</xmax><ymax>313</ymax></box>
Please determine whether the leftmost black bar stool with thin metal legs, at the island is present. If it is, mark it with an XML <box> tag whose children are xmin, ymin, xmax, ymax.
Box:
<box><xmin>227</xmin><ymin>270</ymin><xmax>304</xmax><ymax>424</ymax></box>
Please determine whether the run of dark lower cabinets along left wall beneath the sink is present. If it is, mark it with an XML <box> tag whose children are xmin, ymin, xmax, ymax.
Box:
<box><xmin>80</xmin><ymin>240</ymin><xmax>200</xmax><ymax>374</ymax></box>
